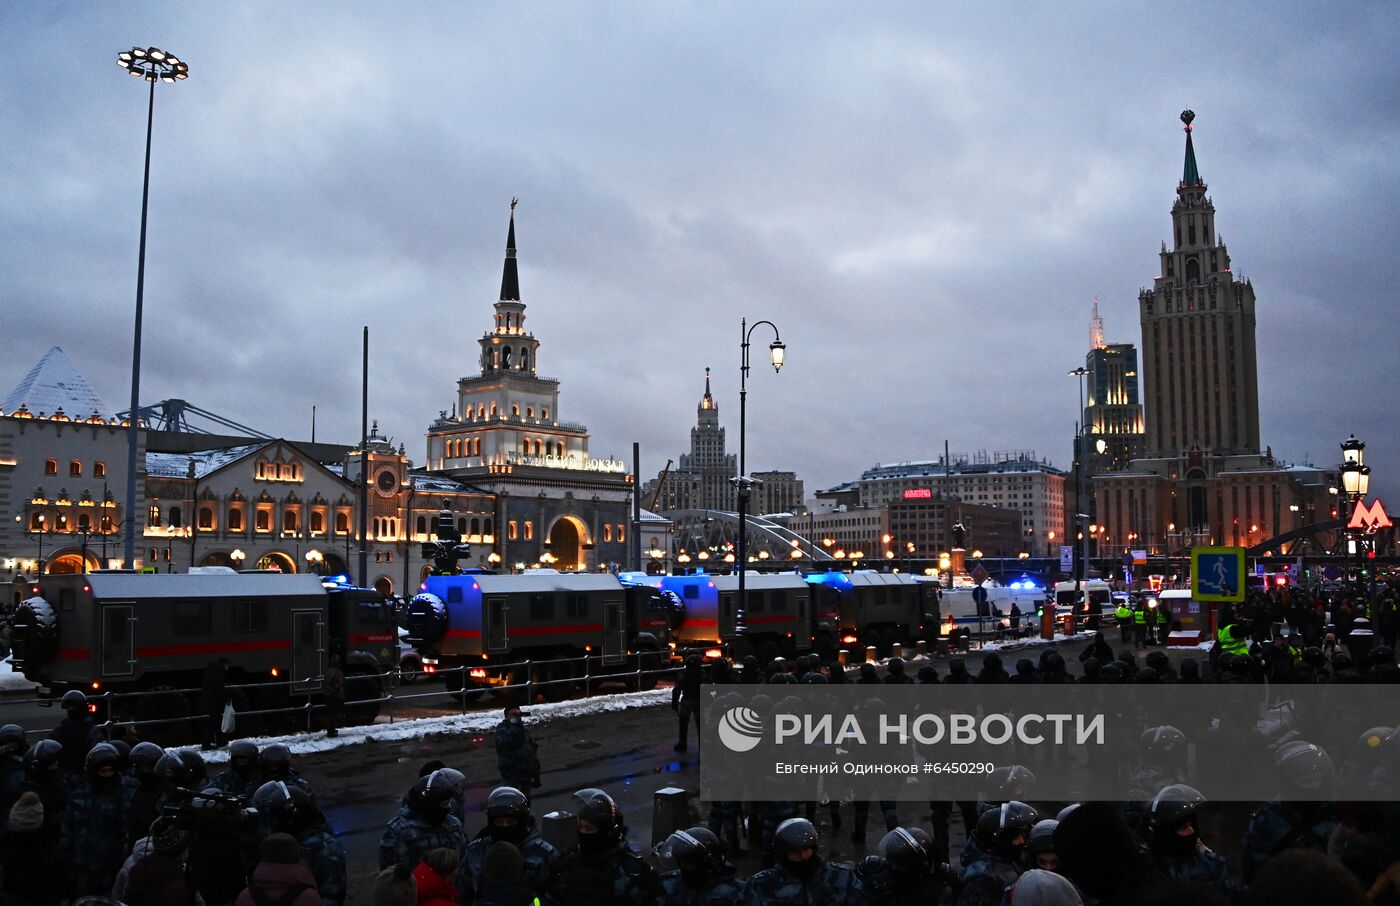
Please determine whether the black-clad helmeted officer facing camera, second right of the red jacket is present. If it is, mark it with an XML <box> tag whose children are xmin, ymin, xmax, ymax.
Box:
<box><xmin>546</xmin><ymin>790</ymin><xmax>661</xmax><ymax>906</ymax></box>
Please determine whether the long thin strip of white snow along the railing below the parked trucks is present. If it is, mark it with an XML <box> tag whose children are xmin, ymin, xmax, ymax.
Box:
<box><xmin>203</xmin><ymin>689</ymin><xmax>671</xmax><ymax>763</ymax></box>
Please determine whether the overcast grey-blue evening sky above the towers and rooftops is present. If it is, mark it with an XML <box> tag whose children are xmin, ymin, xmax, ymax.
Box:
<box><xmin>0</xmin><ymin>1</ymin><xmax>1400</xmax><ymax>492</ymax></box>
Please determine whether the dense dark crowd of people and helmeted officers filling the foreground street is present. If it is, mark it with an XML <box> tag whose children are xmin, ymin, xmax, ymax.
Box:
<box><xmin>0</xmin><ymin>585</ymin><xmax>1400</xmax><ymax>906</ymax></box>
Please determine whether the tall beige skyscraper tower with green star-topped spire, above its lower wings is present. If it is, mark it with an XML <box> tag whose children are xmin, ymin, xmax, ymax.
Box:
<box><xmin>1138</xmin><ymin>111</ymin><xmax>1259</xmax><ymax>458</ymax></box>
